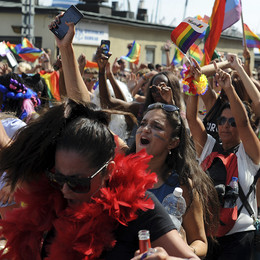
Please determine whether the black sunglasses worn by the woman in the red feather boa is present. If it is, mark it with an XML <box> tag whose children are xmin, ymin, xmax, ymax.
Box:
<box><xmin>45</xmin><ymin>161</ymin><xmax>109</xmax><ymax>193</ymax></box>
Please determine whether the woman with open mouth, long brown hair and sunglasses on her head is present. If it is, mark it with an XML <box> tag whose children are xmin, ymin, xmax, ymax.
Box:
<box><xmin>130</xmin><ymin>103</ymin><xmax>218</xmax><ymax>257</ymax></box>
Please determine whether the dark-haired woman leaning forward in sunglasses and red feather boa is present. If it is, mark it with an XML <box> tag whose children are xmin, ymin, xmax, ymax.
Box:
<box><xmin>0</xmin><ymin>100</ymin><xmax>198</xmax><ymax>260</ymax></box>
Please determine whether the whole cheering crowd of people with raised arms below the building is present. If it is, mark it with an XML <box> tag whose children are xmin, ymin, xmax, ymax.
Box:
<box><xmin>0</xmin><ymin>16</ymin><xmax>260</xmax><ymax>260</ymax></box>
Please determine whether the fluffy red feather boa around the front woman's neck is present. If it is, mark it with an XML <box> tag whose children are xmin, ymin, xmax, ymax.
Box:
<box><xmin>0</xmin><ymin>151</ymin><xmax>157</xmax><ymax>260</ymax></box>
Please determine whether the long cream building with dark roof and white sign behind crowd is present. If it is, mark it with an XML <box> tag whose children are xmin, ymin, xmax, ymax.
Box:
<box><xmin>0</xmin><ymin>1</ymin><xmax>254</xmax><ymax>69</ymax></box>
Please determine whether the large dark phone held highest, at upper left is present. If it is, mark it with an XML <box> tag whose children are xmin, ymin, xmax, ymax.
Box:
<box><xmin>50</xmin><ymin>5</ymin><xmax>83</xmax><ymax>40</ymax></box>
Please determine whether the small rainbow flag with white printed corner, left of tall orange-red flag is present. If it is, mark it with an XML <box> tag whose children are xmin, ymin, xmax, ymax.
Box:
<box><xmin>171</xmin><ymin>17</ymin><xmax>208</xmax><ymax>54</ymax></box>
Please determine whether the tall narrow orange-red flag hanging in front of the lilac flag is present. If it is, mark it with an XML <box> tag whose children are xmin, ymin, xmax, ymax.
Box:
<box><xmin>201</xmin><ymin>0</ymin><xmax>226</xmax><ymax>66</ymax></box>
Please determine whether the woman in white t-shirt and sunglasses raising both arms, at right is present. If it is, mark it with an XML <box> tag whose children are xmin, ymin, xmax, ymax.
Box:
<box><xmin>187</xmin><ymin>63</ymin><xmax>260</xmax><ymax>260</ymax></box>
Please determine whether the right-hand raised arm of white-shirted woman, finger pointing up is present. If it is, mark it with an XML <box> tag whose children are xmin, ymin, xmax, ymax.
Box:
<box><xmin>214</xmin><ymin>63</ymin><xmax>260</xmax><ymax>164</ymax></box>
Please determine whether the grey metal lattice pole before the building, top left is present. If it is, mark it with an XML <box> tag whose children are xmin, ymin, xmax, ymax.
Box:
<box><xmin>21</xmin><ymin>0</ymin><xmax>35</xmax><ymax>44</ymax></box>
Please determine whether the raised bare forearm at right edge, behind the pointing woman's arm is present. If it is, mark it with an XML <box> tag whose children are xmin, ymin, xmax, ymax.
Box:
<box><xmin>227</xmin><ymin>54</ymin><xmax>260</xmax><ymax>116</ymax></box>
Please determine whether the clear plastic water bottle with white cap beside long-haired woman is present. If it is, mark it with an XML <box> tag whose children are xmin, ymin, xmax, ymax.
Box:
<box><xmin>162</xmin><ymin>187</ymin><xmax>186</xmax><ymax>231</ymax></box>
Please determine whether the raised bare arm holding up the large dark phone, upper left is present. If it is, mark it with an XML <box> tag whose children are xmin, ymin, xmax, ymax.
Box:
<box><xmin>49</xmin><ymin>16</ymin><xmax>90</xmax><ymax>102</ymax></box>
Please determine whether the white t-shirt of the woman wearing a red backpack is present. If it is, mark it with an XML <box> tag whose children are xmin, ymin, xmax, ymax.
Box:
<box><xmin>199</xmin><ymin>135</ymin><xmax>260</xmax><ymax>235</ymax></box>
